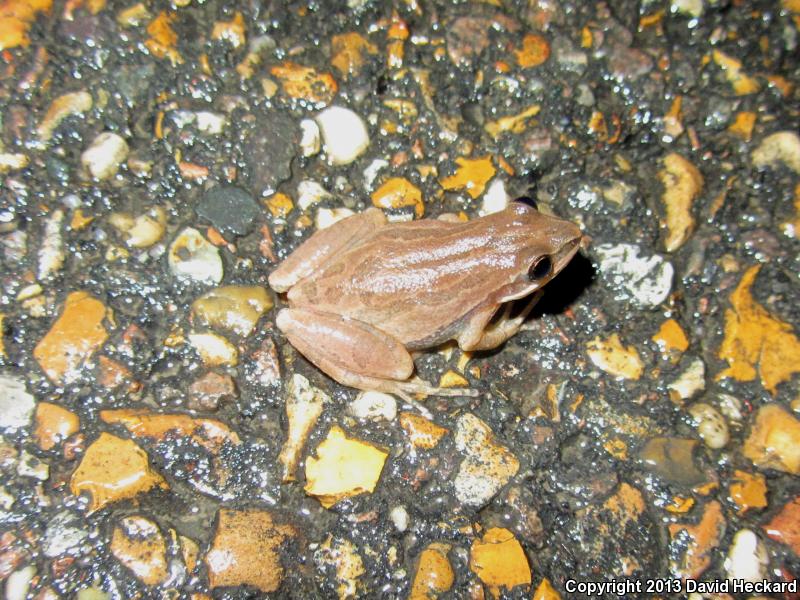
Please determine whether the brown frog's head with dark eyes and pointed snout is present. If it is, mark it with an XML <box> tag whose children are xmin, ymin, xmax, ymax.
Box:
<box><xmin>498</xmin><ymin>197</ymin><xmax>581</xmax><ymax>302</ymax></box>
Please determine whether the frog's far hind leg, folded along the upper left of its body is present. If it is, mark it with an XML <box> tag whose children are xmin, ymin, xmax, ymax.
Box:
<box><xmin>269</xmin><ymin>208</ymin><xmax>386</xmax><ymax>292</ymax></box>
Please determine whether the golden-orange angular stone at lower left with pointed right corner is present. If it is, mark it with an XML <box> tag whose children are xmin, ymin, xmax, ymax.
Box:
<box><xmin>70</xmin><ymin>433</ymin><xmax>167</xmax><ymax>512</ymax></box>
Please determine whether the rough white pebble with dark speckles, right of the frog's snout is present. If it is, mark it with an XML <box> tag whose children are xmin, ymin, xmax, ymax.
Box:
<box><xmin>595</xmin><ymin>244</ymin><xmax>675</xmax><ymax>307</ymax></box>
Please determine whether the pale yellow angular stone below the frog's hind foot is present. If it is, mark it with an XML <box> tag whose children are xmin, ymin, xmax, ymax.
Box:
<box><xmin>305</xmin><ymin>425</ymin><xmax>389</xmax><ymax>508</ymax></box>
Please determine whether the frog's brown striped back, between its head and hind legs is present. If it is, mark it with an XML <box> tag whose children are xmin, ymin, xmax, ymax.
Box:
<box><xmin>289</xmin><ymin>217</ymin><xmax>519</xmax><ymax>347</ymax></box>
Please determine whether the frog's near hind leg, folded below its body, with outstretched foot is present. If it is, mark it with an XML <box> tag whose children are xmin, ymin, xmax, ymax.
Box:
<box><xmin>275</xmin><ymin>308</ymin><xmax>473</xmax><ymax>398</ymax></box>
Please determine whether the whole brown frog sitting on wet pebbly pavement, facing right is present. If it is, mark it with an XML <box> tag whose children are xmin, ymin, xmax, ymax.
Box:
<box><xmin>268</xmin><ymin>197</ymin><xmax>582</xmax><ymax>399</ymax></box>
